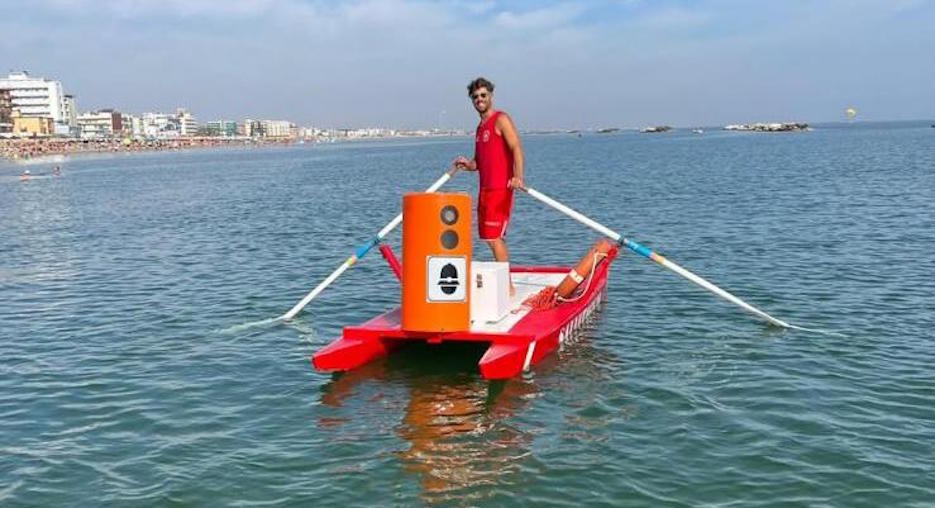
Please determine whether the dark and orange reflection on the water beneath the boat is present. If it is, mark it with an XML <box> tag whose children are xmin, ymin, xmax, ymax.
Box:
<box><xmin>320</xmin><ymin>345</ymin><xmax>538</xmax><ymax>503</ymax></box>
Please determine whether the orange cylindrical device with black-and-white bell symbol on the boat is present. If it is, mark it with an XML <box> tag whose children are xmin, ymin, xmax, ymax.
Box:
<box><xmin>402</xmin><ymin>193</ymin><xmax>471</xmax><ymax>332</ymax></box>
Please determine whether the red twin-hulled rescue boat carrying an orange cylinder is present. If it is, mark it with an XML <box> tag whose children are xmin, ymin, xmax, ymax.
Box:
<box><xmin>312</xmin><ymin>193</ymin><xmax>619</xmax><ymax>379</ymax></box>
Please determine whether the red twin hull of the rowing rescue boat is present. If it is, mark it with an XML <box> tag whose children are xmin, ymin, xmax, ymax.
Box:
<box><xmin>312</xmin><ymin>247</ymin><xmax>618</xmax><ymax>379</ymax></box>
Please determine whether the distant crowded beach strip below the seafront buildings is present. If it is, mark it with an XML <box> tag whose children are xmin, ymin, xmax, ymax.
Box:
<box><xmin>0</xmin><ymin>137</ymin><xmax>293</xmax><ymax>161</ymax></box>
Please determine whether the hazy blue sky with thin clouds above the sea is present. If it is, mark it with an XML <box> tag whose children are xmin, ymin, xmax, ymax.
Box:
<box><xmin>0</xmin><ymin>0</ymin><xmax>935</xmax><ymax>130</ymax></box>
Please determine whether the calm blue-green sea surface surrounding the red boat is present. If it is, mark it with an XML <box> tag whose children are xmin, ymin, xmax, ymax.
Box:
<box><xmin>0</xmin><ymin>124</ymin><xmax>935</xmax><ymax>507</ymax></box>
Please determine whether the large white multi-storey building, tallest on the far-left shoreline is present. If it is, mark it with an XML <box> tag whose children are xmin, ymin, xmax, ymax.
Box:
<box><xmin>0</xmin><ymin>71</ymin><xmax>74</xmax><ymax>135</ymax></box>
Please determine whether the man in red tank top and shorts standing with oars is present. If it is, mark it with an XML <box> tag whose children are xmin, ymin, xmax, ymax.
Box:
<box><xmin>454</xmin><ymin>78</ymin><xmax>524</xmax><ymax>294</ymax></box>
